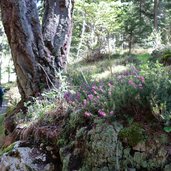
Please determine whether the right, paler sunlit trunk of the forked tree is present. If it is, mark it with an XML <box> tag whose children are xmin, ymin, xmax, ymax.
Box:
<box><xmin>43</xmin><ymin>0</ymin><xmax>73</xmax><ymax>69</ymax></box>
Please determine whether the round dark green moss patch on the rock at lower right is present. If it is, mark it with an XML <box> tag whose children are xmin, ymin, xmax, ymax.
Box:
<box><xmin>119</xmin><ymin>123</ymin><xmax>145</xmax><ymax>146</ymax></box>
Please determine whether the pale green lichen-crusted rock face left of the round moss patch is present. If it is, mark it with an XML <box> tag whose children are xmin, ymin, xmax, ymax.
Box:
<box><xmin>81</xmin><ymin>122</ymin><xmax>123</xmax><ymax>170</ymax></box>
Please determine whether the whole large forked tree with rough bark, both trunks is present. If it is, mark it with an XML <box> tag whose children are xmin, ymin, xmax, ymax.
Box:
<box><xmin>0</xmin><ymin>0</ymin><xmax>73</xmax><ymax>100</ymax></box>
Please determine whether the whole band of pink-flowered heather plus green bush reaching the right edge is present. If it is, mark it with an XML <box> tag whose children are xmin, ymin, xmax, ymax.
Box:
<box><xmin>64</xmin><ymin>64</ymin><xmax>171</xmax><ymax>123</ymax></box>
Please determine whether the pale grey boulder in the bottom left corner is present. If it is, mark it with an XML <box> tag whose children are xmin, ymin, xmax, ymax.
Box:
<box><xmin>0</xmin><ymin>141</ymin><xmax>55</xmax><ymax>171</ymax></box>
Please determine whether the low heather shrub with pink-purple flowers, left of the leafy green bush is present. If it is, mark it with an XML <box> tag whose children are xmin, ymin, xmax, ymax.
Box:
<box><xmin>64</xmin><ymin>67</ymin><xmax>145</xmax><ymax>117</ymax></box>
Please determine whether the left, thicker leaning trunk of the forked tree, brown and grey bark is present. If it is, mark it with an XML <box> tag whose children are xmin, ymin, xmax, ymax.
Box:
<box><xmin>1</xmin><ymin>0</ymin><xmax>54</xmax><ymax>99</ymax></box>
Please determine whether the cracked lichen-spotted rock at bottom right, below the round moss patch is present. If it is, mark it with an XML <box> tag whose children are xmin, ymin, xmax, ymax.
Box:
<box><xmin>121</xmin><ymin>144</ymin><xmax>168</xmax><ymax>170</ymax></box>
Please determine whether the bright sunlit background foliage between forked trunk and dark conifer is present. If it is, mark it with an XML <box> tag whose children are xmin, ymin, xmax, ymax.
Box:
<box><xmin>71</xmin><ymin>0</ymin><xmax>130</xmax><ymax>60</ymax></box>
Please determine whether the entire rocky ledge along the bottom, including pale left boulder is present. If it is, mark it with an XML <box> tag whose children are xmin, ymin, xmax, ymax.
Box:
<box><xmin>0</xmin><ymin>113</ymin><xmax>171</xmax><ymax>171</ymax></box>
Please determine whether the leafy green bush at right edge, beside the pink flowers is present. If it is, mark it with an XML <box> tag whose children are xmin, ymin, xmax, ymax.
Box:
<box><xmin>141</xmin><ymin>63</ymin><xmax>171</xmax><ymax>124</ymax></box>
